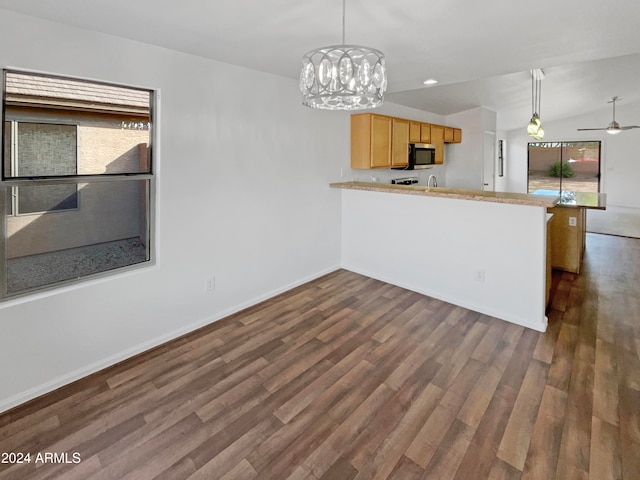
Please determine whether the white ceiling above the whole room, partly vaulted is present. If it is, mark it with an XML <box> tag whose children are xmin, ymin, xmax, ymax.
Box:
<box><xmin>0</xmin><ymin>0</ymin><xmax>640</xmax><ymax>130</ymax></box>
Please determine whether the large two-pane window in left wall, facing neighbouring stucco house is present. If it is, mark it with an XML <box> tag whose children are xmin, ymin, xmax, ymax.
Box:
<box><xmin>0</xmin><ymin>70</ymin><xmax>155</xmax><ymax>299</ymax></box>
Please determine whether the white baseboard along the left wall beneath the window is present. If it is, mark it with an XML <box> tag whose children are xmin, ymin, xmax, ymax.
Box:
<box><xmin>0</xmin><ymin>265</ymin><xmax>341</xmax><ymax>413</ymax></box>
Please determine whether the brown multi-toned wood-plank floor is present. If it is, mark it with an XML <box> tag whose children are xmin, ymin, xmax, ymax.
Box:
<box><xmin>0</xmin><ymin>234</ymin><xmax>640</xmax><ymax>480</ymax></box>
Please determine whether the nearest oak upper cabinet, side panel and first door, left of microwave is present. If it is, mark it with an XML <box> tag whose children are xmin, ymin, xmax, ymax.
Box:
<box><xmin>351</xmin><ymin>113</ymin><xmax>392</xmax><ymax>168</ymax></box>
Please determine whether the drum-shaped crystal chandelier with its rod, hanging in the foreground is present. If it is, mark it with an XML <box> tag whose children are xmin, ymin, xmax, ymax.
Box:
<box><xmin>300</xmin><ymin>0</ymin><xmax>387</xmax><ymax>110</ymax></box>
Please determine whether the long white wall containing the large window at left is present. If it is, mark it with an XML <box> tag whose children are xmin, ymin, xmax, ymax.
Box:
<box><xmin>0</xmin><ymin>11</ymin><xmax>349</xmax><ymax>411</ymax></box>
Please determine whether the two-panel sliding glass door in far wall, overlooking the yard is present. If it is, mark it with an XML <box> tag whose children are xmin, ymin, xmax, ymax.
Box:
<box><xmin>528</xmin><ymin>141</ymin><xmax>600</xmax><ymax>193</ymax></box>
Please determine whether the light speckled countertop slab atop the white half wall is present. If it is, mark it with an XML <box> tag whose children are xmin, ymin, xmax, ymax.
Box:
<box><xmin>329</xmin><ymin>182</ymin><xmax>559</xmax><ymax>208</ymax></box>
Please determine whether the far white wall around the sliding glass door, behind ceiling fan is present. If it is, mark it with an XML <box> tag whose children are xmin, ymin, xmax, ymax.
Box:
<box><xmin>507</xmin><ymin>101</ymin><xmax>640</xmax><ymax>207</ymax></box>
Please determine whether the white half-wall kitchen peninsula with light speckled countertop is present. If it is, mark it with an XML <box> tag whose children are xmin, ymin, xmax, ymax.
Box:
<box><xmin>330</xmin><ymin>182</ymin><xmax>558</xmax><ymax>331</ymax></box>
